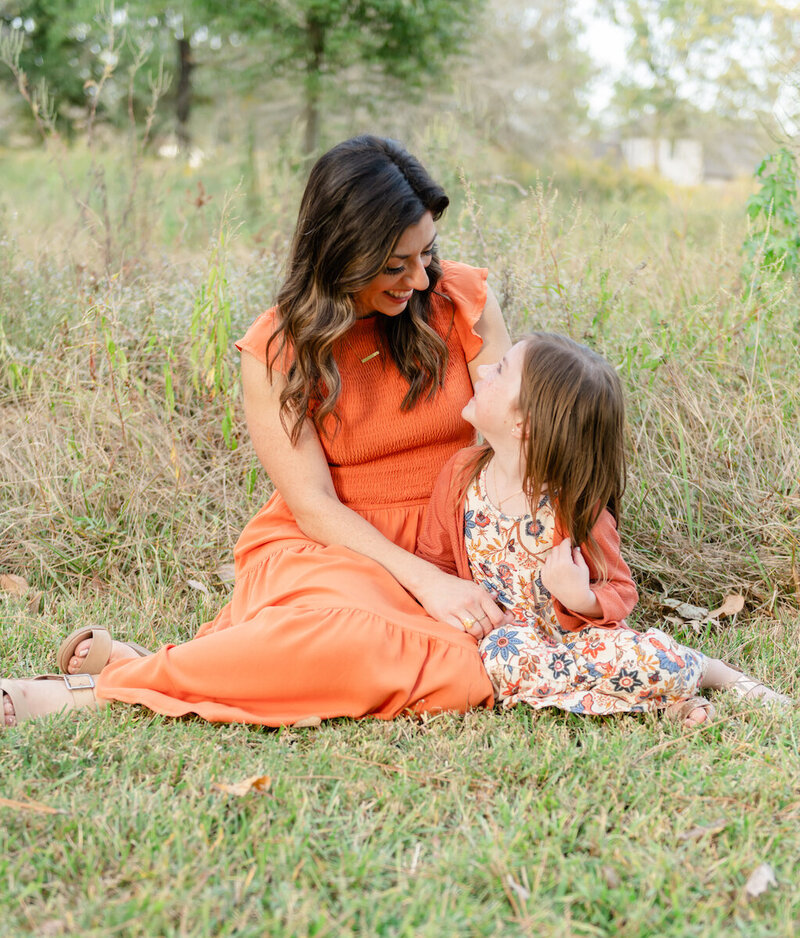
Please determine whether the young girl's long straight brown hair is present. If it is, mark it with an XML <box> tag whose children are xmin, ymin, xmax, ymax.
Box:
<box><xmin>465</xmin><ymin>332</ymin><xmax>626</xmax><ymax>576</ymax></box>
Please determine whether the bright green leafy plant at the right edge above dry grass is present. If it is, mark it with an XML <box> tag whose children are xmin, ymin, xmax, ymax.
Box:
<box><xmin>742</xmin><ymin>147</ymin><xmax>800</xmax><ymax>276</ymax></box>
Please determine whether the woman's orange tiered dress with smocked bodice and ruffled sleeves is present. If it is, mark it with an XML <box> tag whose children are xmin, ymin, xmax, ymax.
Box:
<box><xmin>97</xmin><ymin>262</ymin><xmax>493</xmax><ymax>726</ymax></box>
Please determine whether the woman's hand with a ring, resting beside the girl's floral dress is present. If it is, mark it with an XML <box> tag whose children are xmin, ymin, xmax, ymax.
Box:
<box><xmin>414</xmin><ymin>564</ymin><xmax>511</xmax><ymax>641</ymax></box>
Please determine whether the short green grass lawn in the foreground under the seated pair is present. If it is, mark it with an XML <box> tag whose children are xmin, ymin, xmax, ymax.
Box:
<box><xmin>0</xmin><ymin>601</ymin><xmax>800</xmax><ymax>938</ymax></box>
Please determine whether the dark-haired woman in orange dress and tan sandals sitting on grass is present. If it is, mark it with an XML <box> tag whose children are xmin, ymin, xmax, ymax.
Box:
<box><xmin>2</xmin><ymin>136</ymin><xmax>510</xmax><ymax>726</ymax></box>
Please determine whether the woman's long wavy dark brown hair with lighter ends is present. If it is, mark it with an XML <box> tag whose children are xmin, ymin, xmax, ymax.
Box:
<box><xmin>267</xmin><ymin>135</ymin><xmax>449</xmax><ymax>442</ymax></box>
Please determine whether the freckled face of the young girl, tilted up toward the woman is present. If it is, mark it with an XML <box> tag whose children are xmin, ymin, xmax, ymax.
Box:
<box><xmin>461</xmin><ymin>342</ymin><xmax>526</xmax><ymax>443</ymax></box>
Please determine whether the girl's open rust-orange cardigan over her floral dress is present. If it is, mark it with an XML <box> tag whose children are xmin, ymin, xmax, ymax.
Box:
<box><xmin>416</xmin><ymin>446</ymin><xmax>639</xmax><ymax>632</ymax></box>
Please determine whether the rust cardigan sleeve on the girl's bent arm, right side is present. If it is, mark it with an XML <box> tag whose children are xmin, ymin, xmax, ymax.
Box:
<box><xmin>553</xmin><ymin>509</ymin><xmax>639</xmax><ymax>632</ymax></box>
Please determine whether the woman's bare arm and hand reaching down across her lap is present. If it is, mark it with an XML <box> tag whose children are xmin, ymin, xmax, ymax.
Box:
<box><xmin>242</xmin><ymin>351</ymin><xmax>503</xmax><ymax>638</ymax></box>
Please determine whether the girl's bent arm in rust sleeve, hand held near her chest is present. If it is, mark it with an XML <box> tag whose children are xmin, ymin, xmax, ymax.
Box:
<box><xmin>542</xmin><ymin>510</ymin><xmax>639</xmax><ymax>632</ymax></box>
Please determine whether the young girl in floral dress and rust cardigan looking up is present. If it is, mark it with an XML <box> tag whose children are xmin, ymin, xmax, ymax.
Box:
<box><xmin>418</xmin><ymin>333</ymin><xmax>789</xmax><ymax>725</ymax></box>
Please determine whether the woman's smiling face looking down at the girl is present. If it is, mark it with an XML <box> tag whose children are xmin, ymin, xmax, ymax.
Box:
<box><xmin>353</xmin><ymin>212</ymin><xmax>436</xmax><ymax>319</ymax></box>
